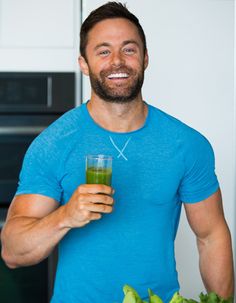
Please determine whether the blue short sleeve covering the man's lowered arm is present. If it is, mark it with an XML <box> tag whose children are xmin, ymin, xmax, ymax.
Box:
<box><xmin>179</xmin><ymin>132</ymin><xmax>219</xmax><ymax>203</ymax></box>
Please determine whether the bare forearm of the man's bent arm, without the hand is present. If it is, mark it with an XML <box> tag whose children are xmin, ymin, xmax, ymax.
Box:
<box><xmin>1</xmin><ymin>207</ymin><xmax>69</xmax><ymax>268</ymax></box>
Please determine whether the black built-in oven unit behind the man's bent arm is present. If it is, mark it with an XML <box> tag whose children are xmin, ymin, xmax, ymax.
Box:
<box><xmin>0</xmin><ymin>73</ymin><xmax>75</xmax><ymax>303</ymax></box>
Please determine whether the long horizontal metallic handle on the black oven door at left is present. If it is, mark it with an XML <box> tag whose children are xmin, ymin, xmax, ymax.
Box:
<box><xmin>0</xmin><ymin>126</ymin><xmax>47</xmax><ymax>135</ymax></box>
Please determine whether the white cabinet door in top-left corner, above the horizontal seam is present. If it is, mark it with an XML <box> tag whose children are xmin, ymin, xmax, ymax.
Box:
<box><xmin>0</xmin><ymin>0</ymin><xmax>74</xmax><ymax>48</ymax></box>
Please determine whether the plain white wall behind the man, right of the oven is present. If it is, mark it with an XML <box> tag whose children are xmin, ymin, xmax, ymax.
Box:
<box><xmin>83</xmin><ymin>0</ymin><xmax>236</xmax><ymax>299</ymax></box>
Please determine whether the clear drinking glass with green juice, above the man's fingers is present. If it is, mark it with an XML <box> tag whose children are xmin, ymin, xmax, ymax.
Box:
<box><xmin>86</xmin><ymin>155</ymin><xmax>112</xmax><ymax>186</ymax></box>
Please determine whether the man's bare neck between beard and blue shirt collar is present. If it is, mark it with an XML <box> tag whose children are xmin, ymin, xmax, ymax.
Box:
<box><xmin>88</xmin><ymin>97</ymin><xmax>147</xmax><ymax>132</ymax></box>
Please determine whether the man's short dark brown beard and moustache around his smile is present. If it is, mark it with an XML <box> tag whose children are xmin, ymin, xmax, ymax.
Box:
<box><xmin>89</xmin><ymin>66</ymin><xmax>144</xmax><ymax>103</ymax></box>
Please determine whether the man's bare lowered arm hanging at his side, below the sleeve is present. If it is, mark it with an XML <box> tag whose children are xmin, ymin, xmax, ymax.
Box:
<box><xmin>185</xmin><ymin>190</ymin><xmax>234</xmax><ymax>298</ymax></box>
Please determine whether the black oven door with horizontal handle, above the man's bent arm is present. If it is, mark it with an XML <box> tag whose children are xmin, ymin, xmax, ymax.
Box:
<box><xmin>0</xmin><ymin>114</ymin><xmax>59</xmax><ymax>204</ymax></box>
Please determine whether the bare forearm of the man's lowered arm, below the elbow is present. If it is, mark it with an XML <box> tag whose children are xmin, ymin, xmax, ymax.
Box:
<box><xmin>198</xmin><ymin>226</ymin><xmax>234</xmax><ymax>298</ymax></box>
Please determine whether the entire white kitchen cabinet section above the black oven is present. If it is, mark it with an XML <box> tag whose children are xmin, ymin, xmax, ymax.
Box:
<box><xmin>0</xmin><ymin>0</ymin><xmax>80</xmax><ymax>71</ymax></box>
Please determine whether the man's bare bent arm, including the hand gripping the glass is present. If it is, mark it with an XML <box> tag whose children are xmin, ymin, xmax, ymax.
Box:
<box><xmin>1</xmin><ymin>185</ymin><xmax>113</xmax><ymax>268</ymax></box>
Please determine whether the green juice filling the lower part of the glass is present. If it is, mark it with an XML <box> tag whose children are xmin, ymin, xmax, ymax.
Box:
<box><xmin>86</xmin><ymin>167</ymin><xmax>112</xmax><ymax>186</ymax></box>
